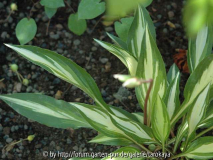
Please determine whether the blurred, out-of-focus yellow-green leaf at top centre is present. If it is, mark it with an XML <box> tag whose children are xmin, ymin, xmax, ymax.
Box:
<box><xmin>106</xmin><ymin>0</ymin><xmax>152</xmax><ymax>21</ymax></box>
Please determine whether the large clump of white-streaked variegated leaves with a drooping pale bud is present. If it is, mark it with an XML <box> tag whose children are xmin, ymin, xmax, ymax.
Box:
<box><xmin>0</xmin><ymin>6</ymin><xmax>213</xmax><ymax>159</ymax></box>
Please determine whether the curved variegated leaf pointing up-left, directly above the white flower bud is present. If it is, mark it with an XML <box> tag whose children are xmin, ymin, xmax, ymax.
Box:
<box><xmin>95</xmin><ymin>39</ymin><xmax>138</xmax><ymax>75</ymax></box>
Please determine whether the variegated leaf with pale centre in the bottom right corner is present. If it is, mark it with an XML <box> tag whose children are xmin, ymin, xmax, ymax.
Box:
<box><xmin>181</xmin><ymin>137</ymin><xmax>213</xmax><ymax>159</ymax></box>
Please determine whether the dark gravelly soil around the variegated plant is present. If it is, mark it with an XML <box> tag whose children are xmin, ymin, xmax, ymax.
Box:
<box><xmin>0</xmin><ymin>0</ymin><xmax>187</xmax><ymax>159</ymax></box>
